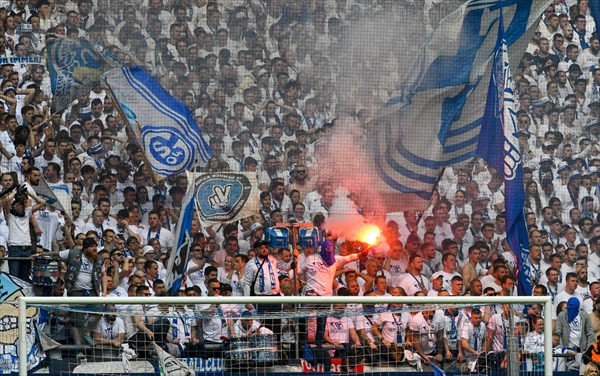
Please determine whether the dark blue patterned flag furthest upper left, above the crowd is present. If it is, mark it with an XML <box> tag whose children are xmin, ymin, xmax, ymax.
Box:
<box><xmin>48</xmin><ymin>38</ymin><xmax>114</xmax><ymax>111</ymax></box>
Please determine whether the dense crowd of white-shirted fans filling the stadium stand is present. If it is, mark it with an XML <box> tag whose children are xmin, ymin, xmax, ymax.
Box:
<box><xmin>0</xmin><ymin>0</ymin><xmax>600</xmax><ymax>370</ymax></box>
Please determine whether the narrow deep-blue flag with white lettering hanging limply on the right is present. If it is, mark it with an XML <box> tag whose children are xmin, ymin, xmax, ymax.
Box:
<box><xmin>477</xmin><ymin>9</ymin><xmax>531</xmax><ymax>296</ymax></box>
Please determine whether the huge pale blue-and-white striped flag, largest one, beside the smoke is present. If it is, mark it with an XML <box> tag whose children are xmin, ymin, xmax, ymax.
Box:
<box><xmin>370</xmin><ymin>0</ymin><xmax>550</xmax><ymax>210</ymax></box>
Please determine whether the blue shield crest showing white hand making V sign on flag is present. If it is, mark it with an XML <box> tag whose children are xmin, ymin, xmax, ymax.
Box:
<box><xmin>196</xmin><ymin>173</ymin><xmax>252</xmax><ymax>222</ymax></box>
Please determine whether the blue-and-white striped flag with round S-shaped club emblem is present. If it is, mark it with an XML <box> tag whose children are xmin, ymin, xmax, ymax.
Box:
<box><xmin>104</xmin><ymin>67</ymin><xmax>212</xmax><ymax>177</ymax></box>
